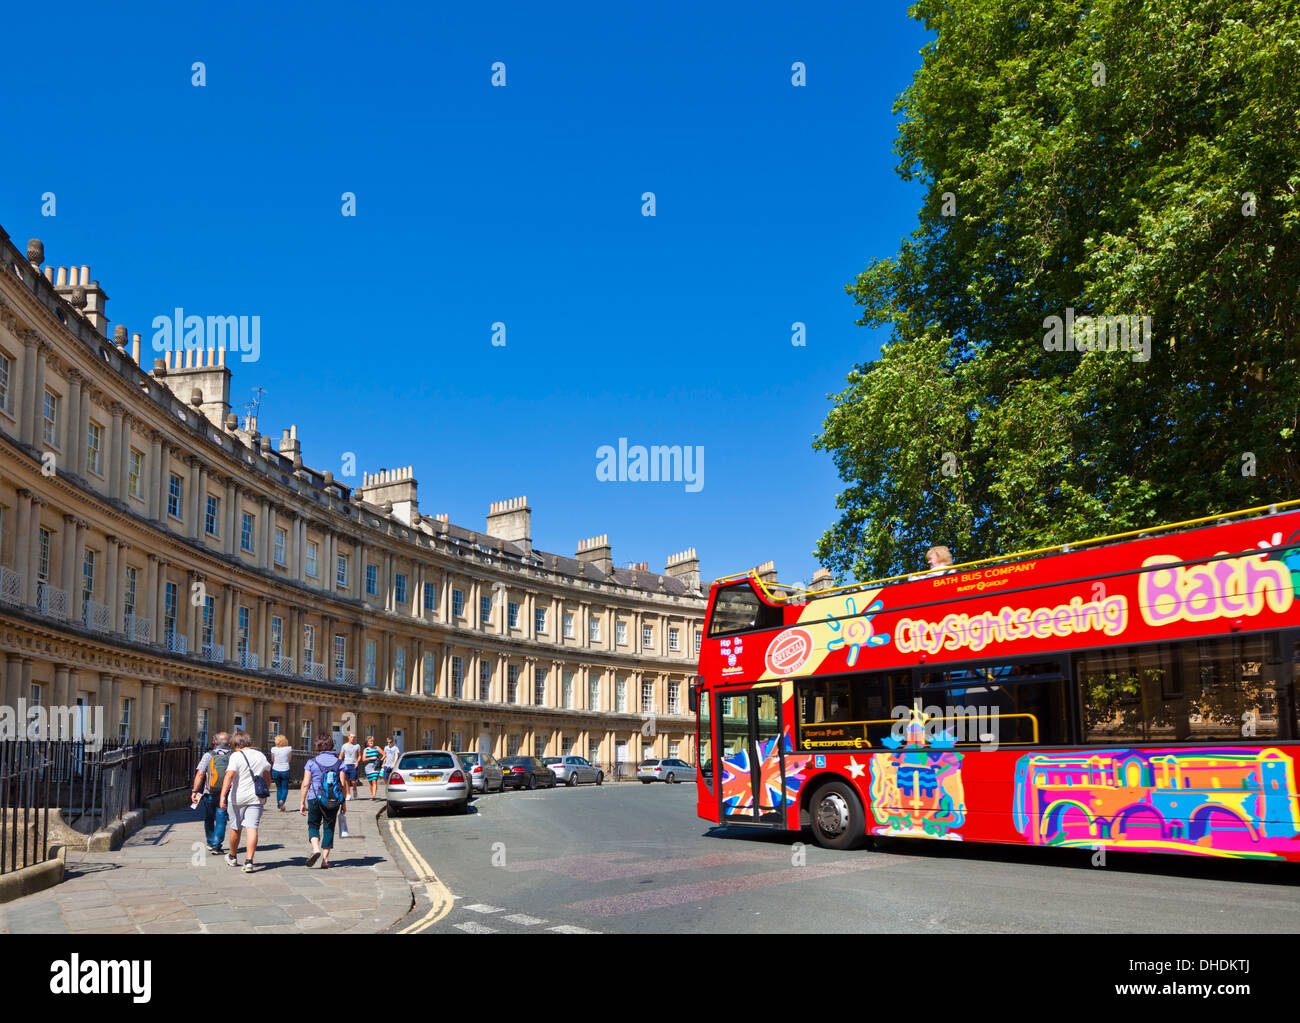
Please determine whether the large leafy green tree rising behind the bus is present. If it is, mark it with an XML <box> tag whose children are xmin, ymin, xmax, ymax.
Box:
<box><xmin>814</xmin><ymin>0</ymin><xmax>1300</xmax><ymax>577</ymax></box>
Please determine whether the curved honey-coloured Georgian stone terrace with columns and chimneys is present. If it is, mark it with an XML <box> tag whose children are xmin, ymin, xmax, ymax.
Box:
<box><xmin>0</xmin><ymin>229</ymin><xmax>705</xmax><ymax>764</ymax></box>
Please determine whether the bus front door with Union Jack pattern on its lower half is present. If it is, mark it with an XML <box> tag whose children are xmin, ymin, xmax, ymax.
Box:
<box><xmin>715</xmin><ymin>688</ymin><xmax>785</xmax><ymax>827</ymax></box>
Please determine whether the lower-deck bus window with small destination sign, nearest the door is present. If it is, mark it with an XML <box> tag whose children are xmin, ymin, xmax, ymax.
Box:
<box><xmin>796</xmin><ymin>671</ymin><xmax>911</xmax><ymax>750</ymax></box>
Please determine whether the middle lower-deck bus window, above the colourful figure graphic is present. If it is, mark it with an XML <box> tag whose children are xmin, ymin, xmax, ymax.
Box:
<box><xmin>920</xmin><ymin>660</ymin><xmax>1070</xmax><ymax>746</ymax></box>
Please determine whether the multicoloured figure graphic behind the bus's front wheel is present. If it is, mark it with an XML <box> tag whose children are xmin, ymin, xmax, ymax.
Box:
<box><xmin>871</xmin><ymin>707</ymin><xmax>966</xmax><ymax>841</ymax></box>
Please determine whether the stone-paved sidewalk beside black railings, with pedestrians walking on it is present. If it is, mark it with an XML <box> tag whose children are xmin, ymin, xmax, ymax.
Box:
<box><xmin>0</xmin><ymin>788</ymin><xmax>412</xmax><ymax>935</ymax></box>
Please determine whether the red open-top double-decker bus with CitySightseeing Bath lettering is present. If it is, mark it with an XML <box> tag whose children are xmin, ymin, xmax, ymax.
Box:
<box><xmin>692</xmin><ymin>502</ymin><xmax>1300</xmax><ymax>861</ymax></box>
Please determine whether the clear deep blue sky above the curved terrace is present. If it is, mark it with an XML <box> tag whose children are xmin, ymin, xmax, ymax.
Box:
<box><xmin>0</xmin><ymin>3</ymin><xmax>928</xmax><ymax>581</ymax></box>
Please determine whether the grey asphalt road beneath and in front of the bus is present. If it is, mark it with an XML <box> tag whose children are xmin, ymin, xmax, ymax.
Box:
<box><xmin>387</xmin><ymin>784</ymin><xmax>1300</xmax><ymax>935</ymax></box>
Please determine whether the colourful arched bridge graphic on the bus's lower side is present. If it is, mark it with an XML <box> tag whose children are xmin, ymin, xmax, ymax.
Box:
<box><xmin>1014</xmin><ymin>747</ymin><xmax>1300</xmax><ymax>858</ymax></box>
